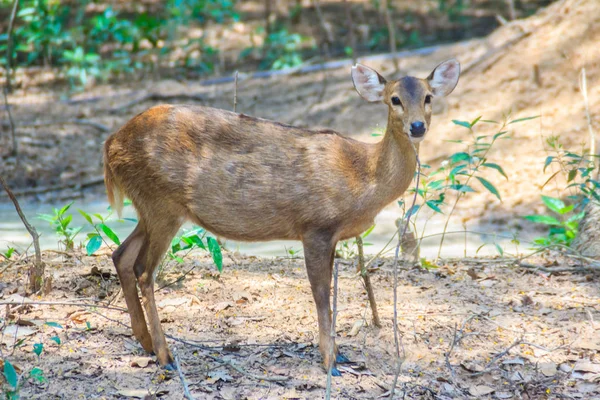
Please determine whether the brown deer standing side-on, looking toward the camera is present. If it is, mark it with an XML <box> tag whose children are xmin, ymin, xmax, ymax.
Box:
<box><xmin>104</xmin><ymin>59</ymin><xmax>460</xmax><ymax>375</ymax></box>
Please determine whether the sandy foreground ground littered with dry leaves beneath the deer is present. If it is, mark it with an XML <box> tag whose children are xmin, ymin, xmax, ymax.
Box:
<box><xmin>0</xmin><ymin>253</ymin><xmax>600</xmax><ymax>399</ymax></box>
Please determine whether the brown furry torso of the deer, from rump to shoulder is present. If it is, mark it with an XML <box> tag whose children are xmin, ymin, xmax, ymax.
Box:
<box><xmin>106</xmin><ymin>106</ymin><xmax>380</xmax><ymax>240</ymax></box>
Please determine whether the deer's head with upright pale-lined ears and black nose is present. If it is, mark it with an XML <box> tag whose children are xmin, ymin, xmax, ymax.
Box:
<box><xmin>352</xmin><ymin>59</ymin><xmax>460</xmax><ymax>143</ymax></box>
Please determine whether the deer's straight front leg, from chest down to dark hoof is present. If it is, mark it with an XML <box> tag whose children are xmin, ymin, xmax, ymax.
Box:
<box><xmin>302</xmin><ymin>233</ymin><xmax>346</xmax><ymax>376</ymax></box>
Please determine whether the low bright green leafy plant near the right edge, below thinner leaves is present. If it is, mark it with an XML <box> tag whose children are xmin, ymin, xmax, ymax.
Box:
<box><xmin>524</xmin><ymin>196</ymin><xmax>584</xmax><ymax>246</ymax></box>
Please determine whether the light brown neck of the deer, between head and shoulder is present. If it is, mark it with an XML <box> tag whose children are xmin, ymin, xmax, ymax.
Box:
<box><xmin>373</xmin><ymin>117</ymin><xmax>419</xmax><ymax>204</ymax></box>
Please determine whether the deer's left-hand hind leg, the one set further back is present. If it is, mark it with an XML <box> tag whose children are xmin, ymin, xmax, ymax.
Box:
<box><xmin>112</xmin><ymin>223</ymin><xmax>153</xmax><ymax>353</ymax></box>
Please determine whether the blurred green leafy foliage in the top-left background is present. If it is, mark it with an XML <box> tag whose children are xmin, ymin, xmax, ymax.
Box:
<box><xmin>0</xmin><ymin>0</ymin><xmax>239</xmax><ymax>89</ymax></box>
